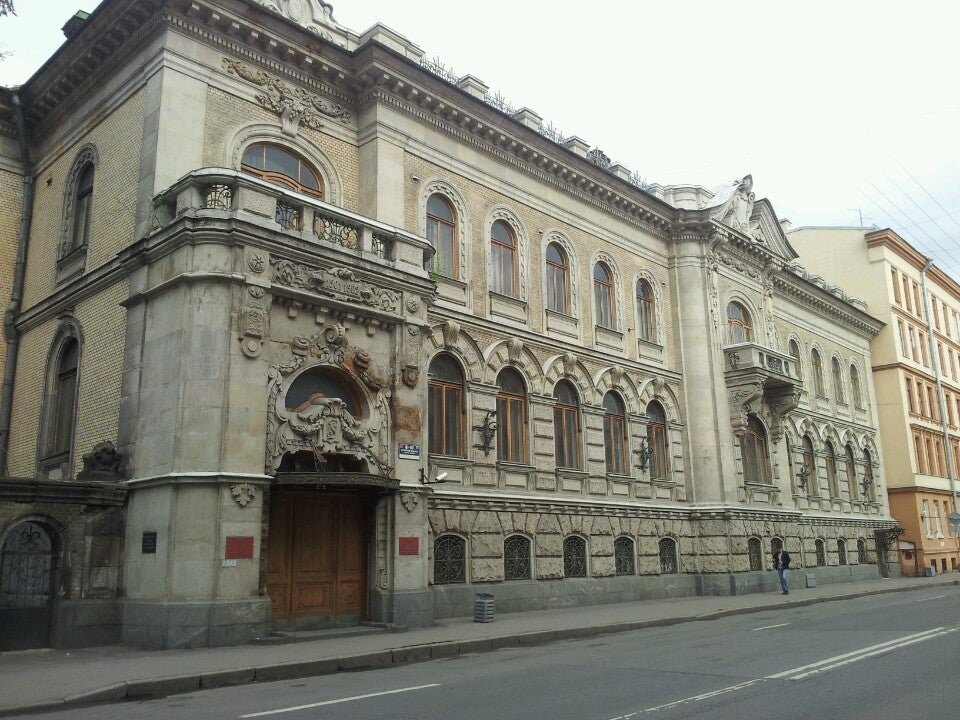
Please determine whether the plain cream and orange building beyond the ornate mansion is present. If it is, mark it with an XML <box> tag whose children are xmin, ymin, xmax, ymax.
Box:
<box><xmin>787</xmin><ymin>228</ymin><xmax>960</xmax><ymax>575</ymax></box>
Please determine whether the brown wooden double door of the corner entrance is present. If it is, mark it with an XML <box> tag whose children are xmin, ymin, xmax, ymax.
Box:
<box><xmin>267</xmin><ymin>491</ymin><xmax>366</xmax><ymax>630</ymax></box>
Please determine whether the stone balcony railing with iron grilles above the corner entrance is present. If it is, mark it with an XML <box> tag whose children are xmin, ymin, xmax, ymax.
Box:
<box><xmin>154</xmin><ymin>168</ymin><xmax>434</xmax><ymax>273</ymax></box>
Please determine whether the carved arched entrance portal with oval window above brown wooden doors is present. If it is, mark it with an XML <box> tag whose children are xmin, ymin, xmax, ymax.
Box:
<box><xmin>265</xmin><ymin>366</ymin><xmax>399</xmax><ymax>630</ymax></box>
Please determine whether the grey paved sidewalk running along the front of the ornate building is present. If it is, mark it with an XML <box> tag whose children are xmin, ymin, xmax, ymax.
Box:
<box><xmin>0</xmin><ymin>576</ymin><xmax>960</xmax><ymax>716</ymax></box>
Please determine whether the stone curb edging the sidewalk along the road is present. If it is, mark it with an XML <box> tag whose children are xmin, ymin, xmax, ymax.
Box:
<box><xmin>0</xmin><ymin>580</ymin><xmax>960</xmax><ymax>718</ymax></box>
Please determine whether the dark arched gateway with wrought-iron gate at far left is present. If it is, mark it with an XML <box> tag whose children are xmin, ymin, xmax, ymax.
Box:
<box><xmin>0</xmin><ymin>522</ymin><xmax>55</xmax><ymax>650</ymax></box>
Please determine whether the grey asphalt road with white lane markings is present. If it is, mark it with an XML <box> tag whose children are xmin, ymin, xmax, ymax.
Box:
<box><xmin>11</xmin><ymin>586</ymin><xmax>960</xmax><ymax>720</ymax></box>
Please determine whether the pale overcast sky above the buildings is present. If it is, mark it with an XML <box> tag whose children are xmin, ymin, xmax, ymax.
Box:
<box><xmin>0</xmin><ymin>0</ymin><xmax>960</xmax><ymax>278</ymax></box>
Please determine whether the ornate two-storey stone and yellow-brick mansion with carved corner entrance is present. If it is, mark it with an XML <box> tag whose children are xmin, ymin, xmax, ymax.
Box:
<box><xmin>0</xmin><ymin>0</ymin><xmax>893</xmax><ymax>647</ymax></box>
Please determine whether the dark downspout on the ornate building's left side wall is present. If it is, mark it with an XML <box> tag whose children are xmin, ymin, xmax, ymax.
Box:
<box><xmin>0</xmin><ymin>92</ymin><xmax>33</xmax><ymax>475</ymax></box>
